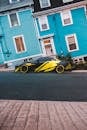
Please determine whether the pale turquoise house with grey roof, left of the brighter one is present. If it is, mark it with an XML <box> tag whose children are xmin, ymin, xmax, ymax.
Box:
<box><xmin>0</xmin><ymin>0</ymin><xmax>41</xmax><ymax>64</ymax></box>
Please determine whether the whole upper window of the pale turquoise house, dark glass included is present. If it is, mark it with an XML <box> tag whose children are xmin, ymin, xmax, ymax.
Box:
<box><xmin>9</xmin><ymin>13</ymin><xmax>19</xmax><ymax>27</ymax></box>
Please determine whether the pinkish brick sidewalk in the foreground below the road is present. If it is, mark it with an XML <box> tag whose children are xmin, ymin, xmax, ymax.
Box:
<box><xmin>0</xmin><ymin>100</ymin><xmax>87</xmax><ymax>130</ymax></box>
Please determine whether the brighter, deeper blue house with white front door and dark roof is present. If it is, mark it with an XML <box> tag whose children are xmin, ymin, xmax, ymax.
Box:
<box><xmin>34</xmin><ymin>0</ymin><xmax>87</xmax><ymax>62</ymax></box>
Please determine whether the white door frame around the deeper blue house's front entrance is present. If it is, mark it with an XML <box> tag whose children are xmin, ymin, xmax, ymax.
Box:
<box><xmin>41</xmin><ymin>37</ymin><xmax>56</xmax><ymax>55</ymax></box>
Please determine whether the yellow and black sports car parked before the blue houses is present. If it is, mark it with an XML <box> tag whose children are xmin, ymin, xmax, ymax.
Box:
<box><xmin>15</xmin><ymin>57</ymin><xmax>72</xmax><ymax>73</ymax></box>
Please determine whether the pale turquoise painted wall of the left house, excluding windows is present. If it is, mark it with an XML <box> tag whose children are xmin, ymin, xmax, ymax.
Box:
<box><xmin>0</xmin><ymin>10</ymin><xmax>41</xmax><ymax>62</ymax></box>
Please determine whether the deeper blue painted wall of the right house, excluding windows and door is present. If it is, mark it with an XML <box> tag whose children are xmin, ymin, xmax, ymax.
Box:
<box><xmin>37</xmin><ymin>7</ymin><xmax>87</xmax><ymax>57</ymax></box>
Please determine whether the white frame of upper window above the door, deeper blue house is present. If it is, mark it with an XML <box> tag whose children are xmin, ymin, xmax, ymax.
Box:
<box><xmin>38</xmin><ymin>15</ymin><xmax>49</xmax><ymax>31</ymax></box>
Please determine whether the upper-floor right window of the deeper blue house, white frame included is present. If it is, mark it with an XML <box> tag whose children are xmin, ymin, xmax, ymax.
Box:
<box><xmin>61</xmin><ymin>10</ymin><xmax>73</xmax><ymax>26</ymax></box>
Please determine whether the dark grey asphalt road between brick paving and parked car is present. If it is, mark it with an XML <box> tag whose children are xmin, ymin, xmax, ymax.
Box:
<box><xmin>0</xmin><ymin>72</ymin><xmax>87</xmax><ymax>101</ymax></box>
